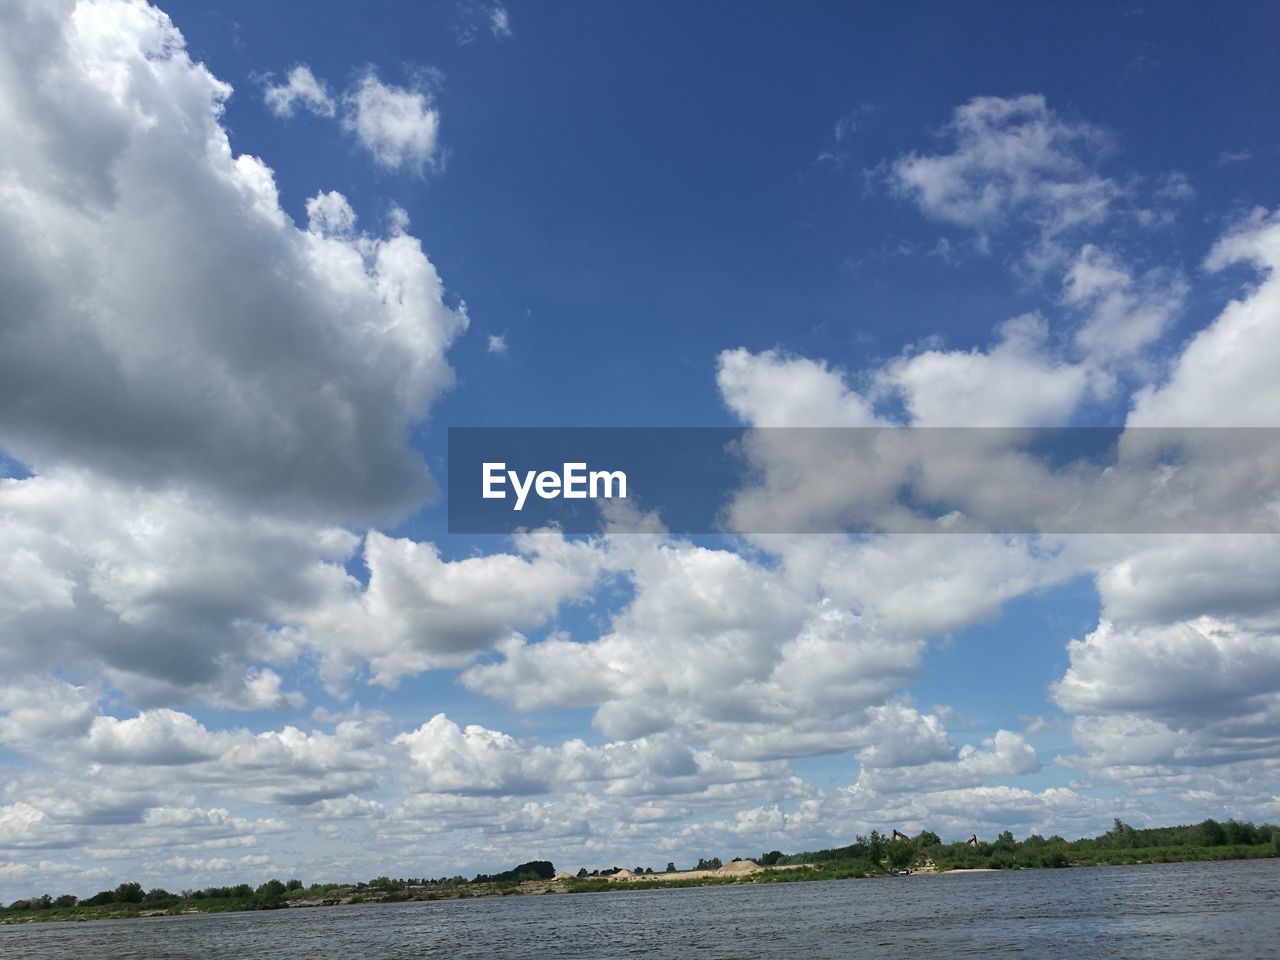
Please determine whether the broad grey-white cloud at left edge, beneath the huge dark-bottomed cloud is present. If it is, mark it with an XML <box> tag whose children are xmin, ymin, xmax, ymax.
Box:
<box><xmin>0</xmin><ymin>470</ymin><xmax>357</xmax><ymax>709</ymax></box>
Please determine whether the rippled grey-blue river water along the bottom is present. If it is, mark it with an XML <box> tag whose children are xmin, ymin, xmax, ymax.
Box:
<box><xmin>0</xmin><ymin>860</ymin><xmax>1280</xmax><ymax>960</ymax></box>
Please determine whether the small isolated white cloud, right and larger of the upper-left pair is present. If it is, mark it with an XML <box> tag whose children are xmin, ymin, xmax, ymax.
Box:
<box><xmin>342</xmin><ymin>70</ymin><xmax>440</xmax><ymax>174</ymax></box>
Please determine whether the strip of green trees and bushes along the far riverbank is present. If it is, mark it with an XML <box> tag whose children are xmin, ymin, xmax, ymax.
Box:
<box><xmin>0</xmin><ymin>819</ymin><xmax>1280</xmax><ymax>923</ymax></box>
